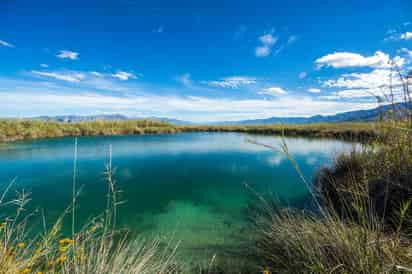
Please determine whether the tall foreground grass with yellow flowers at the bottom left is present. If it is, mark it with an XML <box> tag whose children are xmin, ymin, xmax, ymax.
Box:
<box><xmin>0</xmin><ymin>141</ymin><xmax>178</xmax><ymax>274</ymax></box>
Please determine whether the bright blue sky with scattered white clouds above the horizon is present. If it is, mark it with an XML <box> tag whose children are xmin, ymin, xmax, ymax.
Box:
<box><xmin>0</xmin><ymin>0</ymin><xmax>412</xmax><ymax>122</ymax></box>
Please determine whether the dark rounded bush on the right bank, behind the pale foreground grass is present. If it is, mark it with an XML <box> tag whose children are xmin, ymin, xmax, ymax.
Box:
<box><xmin>315</xmin><ymin>124</ymin><xmax>412</xmax><ymax>229</ymax></box>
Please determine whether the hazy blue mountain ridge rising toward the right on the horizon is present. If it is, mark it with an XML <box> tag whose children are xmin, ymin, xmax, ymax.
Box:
<box><xmin>219</xmin><ymin>103</ymin><xmax>405</xmax><ymax>125</ymax></box>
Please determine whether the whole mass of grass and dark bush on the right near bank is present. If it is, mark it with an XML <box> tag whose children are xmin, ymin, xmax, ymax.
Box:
<box><xmin>251</xmin><ymin>121</ymin><xmax>412</xmax><ymax>273</ymax></box>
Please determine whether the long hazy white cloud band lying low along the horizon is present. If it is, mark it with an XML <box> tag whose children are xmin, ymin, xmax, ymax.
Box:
<box><xmin>0</xmin><ymin>79</ymin><xmax>375</xmax><ymax>122</ymax></box>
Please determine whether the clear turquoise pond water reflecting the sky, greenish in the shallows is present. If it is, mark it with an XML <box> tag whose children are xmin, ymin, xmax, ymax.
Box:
<box><xmin>0</xmin><ymin>133</ymin><xmax>353</xmax><ymax>266</ymax></box>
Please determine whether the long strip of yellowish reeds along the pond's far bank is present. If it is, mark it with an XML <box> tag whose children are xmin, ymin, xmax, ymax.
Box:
<box><xmin>0</xmin><ymin>120</ymin><xmax>379</xmax><ymax>142</ymax></box>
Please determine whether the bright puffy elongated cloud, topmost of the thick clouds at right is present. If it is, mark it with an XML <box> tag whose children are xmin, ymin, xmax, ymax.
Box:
<box><xmin>315</xmin><ymin>51</ymin><xmax>390</xmax><ymax>68</ymax></box>
